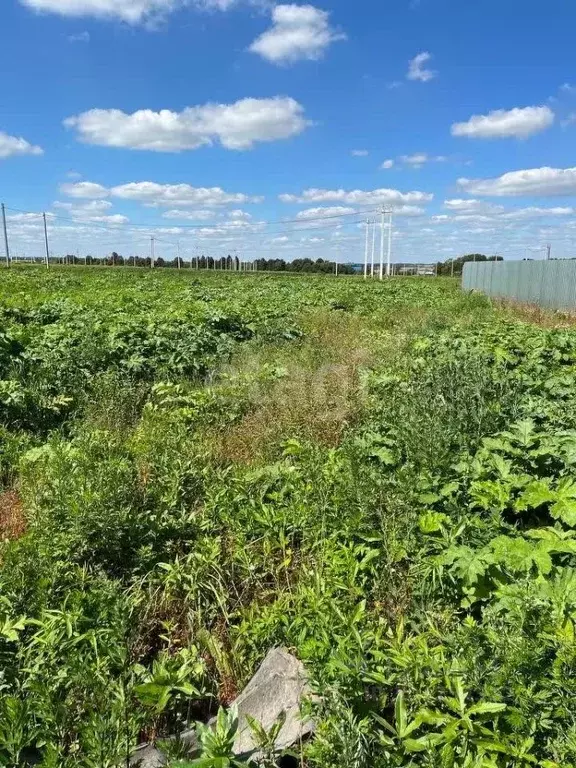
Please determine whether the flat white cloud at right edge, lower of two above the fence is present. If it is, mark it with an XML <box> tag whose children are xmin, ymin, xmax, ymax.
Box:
<box><xmin>457</xmin><ymin>167</ymin><xmax>576</xmax><ymax>197</ymax></box>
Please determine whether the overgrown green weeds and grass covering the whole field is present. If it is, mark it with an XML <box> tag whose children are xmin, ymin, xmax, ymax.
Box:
<box><xmin>0</xmin><ymin>269</ymin><xmax>576</xmax><ymax>768</ymax></box>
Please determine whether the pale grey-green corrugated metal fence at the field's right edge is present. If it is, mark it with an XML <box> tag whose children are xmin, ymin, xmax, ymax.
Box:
<box><xmin>462</xmin><ymin>261</ymin><xmax>576</xmax><ymax>309</ymax></box>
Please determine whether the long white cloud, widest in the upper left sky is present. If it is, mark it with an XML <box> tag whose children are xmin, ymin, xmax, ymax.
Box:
<box><xmin>64</xmin><ymin>96</ymin><xmax>310</xmax><ymax>152</ymax></box>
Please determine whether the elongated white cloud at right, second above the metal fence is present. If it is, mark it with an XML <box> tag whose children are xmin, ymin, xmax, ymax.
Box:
<box><xmin>451</xmin><ymin>107</ymin><xmax>554</xmax><ymax>139</ymax></box>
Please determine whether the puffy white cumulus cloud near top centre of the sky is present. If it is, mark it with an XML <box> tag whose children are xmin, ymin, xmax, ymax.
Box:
<box><xmin>249</xmin><ymin>4</ymin><xmax>346</xmax><ymax>64</ymax></box>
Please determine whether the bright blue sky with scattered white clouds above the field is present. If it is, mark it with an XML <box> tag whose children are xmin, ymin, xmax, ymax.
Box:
<box><xmin>0</xmin><ymin>0</ymin><xmax>576</xmax><ymax>261</ymax></box>
